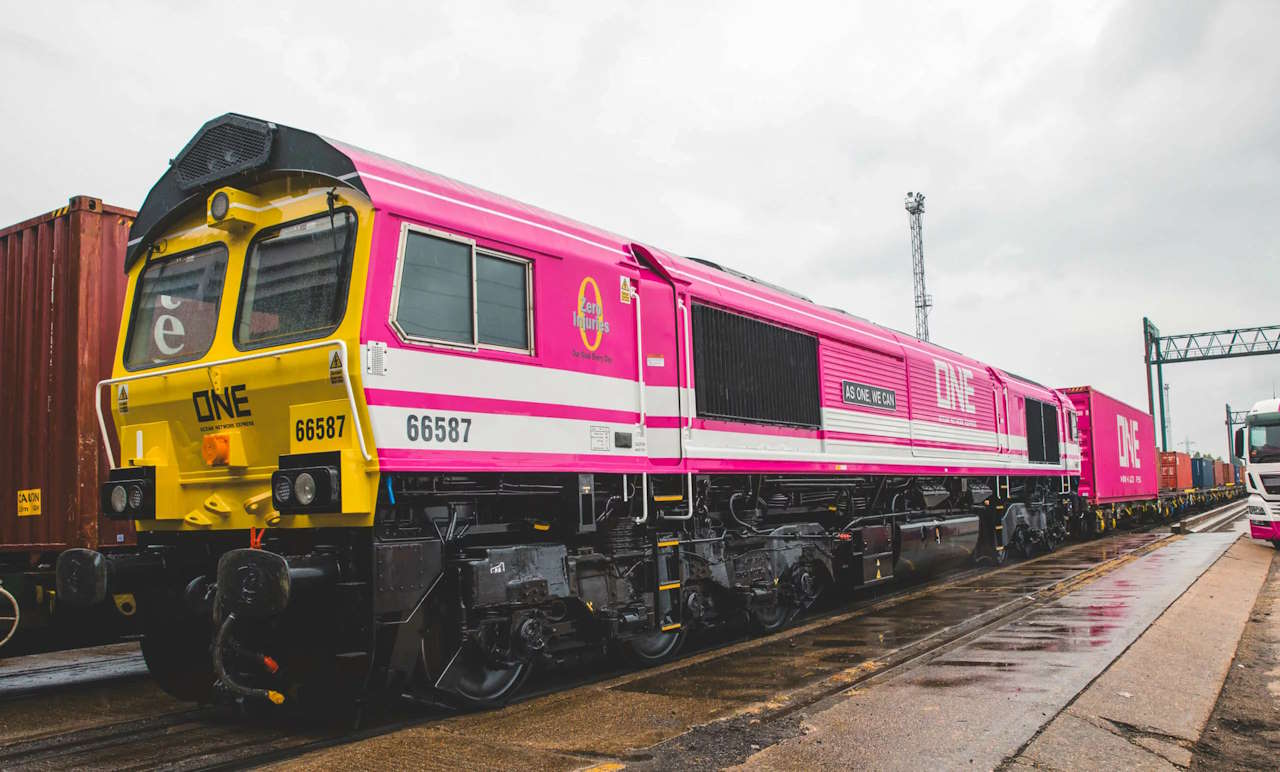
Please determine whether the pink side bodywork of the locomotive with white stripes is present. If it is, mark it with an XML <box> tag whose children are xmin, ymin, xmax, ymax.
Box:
<box><xmin>335</xmin><ymin>138</ymin><xmax>1065</xmax><ymax>475</ymax></box>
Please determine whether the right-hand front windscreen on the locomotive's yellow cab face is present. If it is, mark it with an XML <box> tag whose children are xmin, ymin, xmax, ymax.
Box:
<box><xmin>236</xmin><ymin>210</ymin><xmax>356</xmax><ymax>348</ymax></box>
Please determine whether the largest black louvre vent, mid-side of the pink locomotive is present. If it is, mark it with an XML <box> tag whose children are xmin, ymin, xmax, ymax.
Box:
<box><xmin>694</xmin><ymin>305</ymin><xmax>822</xmax><ymax>428</ymax></box>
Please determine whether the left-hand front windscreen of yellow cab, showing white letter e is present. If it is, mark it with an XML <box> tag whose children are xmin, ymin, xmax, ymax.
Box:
<box><xmin>124</xmin><ymin>243</ymin><xmax>227</xmax><ymax>370</ymax></box>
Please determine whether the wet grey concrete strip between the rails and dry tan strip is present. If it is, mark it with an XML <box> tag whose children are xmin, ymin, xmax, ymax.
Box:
<box><xmin>745</xmin><ymin>533</ymin><xmax>1238</xmax><ymax>769</ymax></box>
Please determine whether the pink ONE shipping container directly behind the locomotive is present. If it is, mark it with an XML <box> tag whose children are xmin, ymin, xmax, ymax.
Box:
<box><xmin>1062</xmin><ymin>387</ymin><xmax>1160</xmax><ymax>504</ymax></box>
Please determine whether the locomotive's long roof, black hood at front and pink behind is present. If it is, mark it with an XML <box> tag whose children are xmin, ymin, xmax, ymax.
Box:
<box><xmin>125</xmin><ymin>113</ymin><xmax>1053</xmax><ymax>393</ymax></box>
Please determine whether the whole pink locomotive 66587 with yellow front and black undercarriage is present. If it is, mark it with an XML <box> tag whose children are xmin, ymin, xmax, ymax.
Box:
<box><xmin>59</xmin><ymin>115</ymin><xmax>1105</xmax><ymax>703</ymax></box>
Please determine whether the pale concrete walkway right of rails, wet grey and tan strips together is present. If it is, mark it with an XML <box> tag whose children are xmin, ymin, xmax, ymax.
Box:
<box><xmin>744</xmin><ymin>534</ymin><xmax>1274</xmax><ymax>769</ymax></box>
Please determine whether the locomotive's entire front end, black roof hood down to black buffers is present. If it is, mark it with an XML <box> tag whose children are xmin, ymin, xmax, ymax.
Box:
<box><xmin>58</xmin><ymin>115</ymin><xmax>391</xmax><ymax>702</ymax></box>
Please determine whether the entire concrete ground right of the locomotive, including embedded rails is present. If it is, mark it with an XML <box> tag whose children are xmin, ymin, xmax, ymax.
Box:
<box><xmin>272</xmin><ymin>534</ymin><xmax>1280</xmax><ymax>771</ymax></box>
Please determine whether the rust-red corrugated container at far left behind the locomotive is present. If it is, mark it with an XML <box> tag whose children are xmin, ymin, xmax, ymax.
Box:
<box><xmin>0</xmin><ymin>196</ymin><xmax>136</xmax><ymax>562</ymax></box>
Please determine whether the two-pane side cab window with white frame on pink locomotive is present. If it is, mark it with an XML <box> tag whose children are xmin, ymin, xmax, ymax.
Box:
<box><xmin>392</xmin><ymin>228</ymin><xmax>532</xmax><ymax>352</ymax></box>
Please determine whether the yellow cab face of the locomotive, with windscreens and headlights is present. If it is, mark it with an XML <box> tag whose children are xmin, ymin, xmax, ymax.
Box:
<box><xmin>102</xmin><ymin>175</ymin><xmax>376</xmax><ymax>533</ymax></box>
